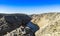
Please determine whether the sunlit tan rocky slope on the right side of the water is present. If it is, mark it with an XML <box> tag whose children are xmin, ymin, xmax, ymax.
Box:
<box><xmin>31</xmin><ymin>13</ymin><xmax>60</xmax><ymax>36</ymax></box>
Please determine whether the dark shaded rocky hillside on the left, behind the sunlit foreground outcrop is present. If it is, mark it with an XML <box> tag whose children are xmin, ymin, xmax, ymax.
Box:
<box><xmin>0</xmin><ymin>14</ymin><xmax>31</xmax><ymax>36</ymax></box>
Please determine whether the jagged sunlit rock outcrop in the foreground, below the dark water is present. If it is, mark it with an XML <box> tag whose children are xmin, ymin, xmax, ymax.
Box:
<box><xmin>4</xmin><ymin>26</ymin><xmax>35</xmax><ymax>36</ymax></box>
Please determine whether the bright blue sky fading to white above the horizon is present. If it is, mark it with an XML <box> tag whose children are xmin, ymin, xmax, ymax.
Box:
<box><xmin>0</xmin><ymin>0</ymin><xmax>60</xmax><ymax>14</ymax></box>
